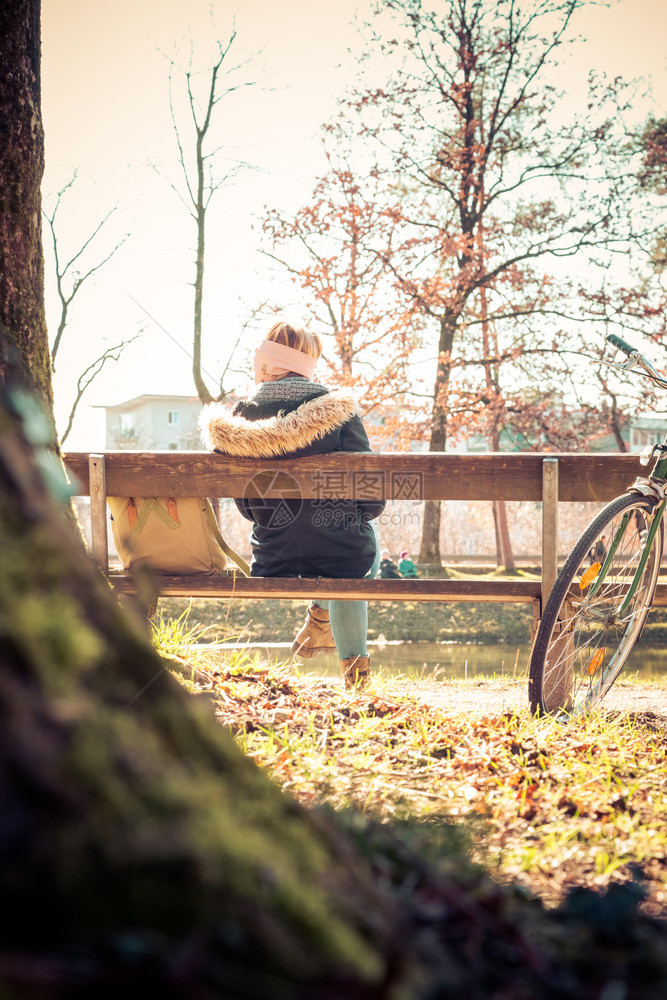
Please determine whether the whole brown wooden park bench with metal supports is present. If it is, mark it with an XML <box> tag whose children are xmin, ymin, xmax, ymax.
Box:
<box><xmin>64</xmin><ymin>451</ymin><xmax>667</xmax><ymax>619</ymax></box>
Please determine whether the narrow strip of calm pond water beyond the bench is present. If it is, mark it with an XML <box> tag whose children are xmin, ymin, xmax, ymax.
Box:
<box><xmin>204</xmin><ymin>642</ymin><xmax>667</xmax><ymax>680</ymax></box>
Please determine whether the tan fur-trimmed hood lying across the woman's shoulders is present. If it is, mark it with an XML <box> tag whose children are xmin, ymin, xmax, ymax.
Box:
<box><xmin>199</xmin><ymin>389</ymin><xmax>358</xmax><ymax>458</ymax></box>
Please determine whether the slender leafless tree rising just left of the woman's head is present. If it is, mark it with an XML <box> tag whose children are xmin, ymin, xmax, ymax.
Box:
<box><xmin>162</xmin><ymin>30</ymin><xmax>254</xmax><ymax>403</ymax></box>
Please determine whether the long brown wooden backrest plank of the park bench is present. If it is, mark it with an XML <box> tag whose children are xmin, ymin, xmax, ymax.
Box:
<box><xmin>65</xmin><ymin>451</ymin><xmax>641</xmax><ymax>501</ymax></box>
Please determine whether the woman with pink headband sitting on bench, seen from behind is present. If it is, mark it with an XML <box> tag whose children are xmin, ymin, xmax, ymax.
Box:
<box><xmin>202</xmin><ymin>323</ymin><xmax>385</xmax><ymax>687</ymax></box>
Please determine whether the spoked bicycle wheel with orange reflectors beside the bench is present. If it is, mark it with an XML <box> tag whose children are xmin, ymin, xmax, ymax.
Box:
<box><xmin>528</xmin><ymin>493</ymin><xmax>664</xmax><ymax>716</ymax></box>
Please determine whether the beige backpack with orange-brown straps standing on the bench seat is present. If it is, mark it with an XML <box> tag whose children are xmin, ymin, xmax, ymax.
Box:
<box><xmin>107</xmin><ymin>497</ymin><xmax>250</xmax><ymax>576</ymax></box>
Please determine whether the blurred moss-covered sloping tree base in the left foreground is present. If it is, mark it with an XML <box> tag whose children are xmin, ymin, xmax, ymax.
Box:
<box><xmin>0</xmin><ymin>392</ymin><xmax>394</xmax><ymax>998</ymax></box>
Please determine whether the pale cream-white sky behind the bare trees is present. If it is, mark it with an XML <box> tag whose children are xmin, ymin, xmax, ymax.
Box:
<box><xmin>42</xmin><ymin>0</ymin><xmax>667</xmax><ymax>449</ymax></box>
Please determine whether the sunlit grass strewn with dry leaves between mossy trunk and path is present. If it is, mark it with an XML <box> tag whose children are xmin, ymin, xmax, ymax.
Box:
<box><xmin>151</xmin><ymin>619</ymin><xmax>667</xmax><ymax>915</ymax></box>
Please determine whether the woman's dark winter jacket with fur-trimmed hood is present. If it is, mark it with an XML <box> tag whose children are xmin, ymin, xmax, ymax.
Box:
<box><xmin>201</xmin><ymin>376</ymin><xmax>385</xmax><ymax>578</ymax></box>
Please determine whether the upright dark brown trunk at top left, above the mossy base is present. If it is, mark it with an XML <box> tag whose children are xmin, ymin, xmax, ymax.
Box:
<box><xmin>0</xmin><ymin>0</ymin><xmax>56</xmax><ymax>445</ymax></box>
